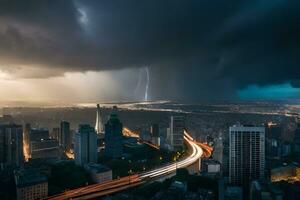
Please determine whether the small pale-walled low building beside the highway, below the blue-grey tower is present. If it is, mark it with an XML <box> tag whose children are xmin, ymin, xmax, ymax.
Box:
<box><xmin>84</xmin><ymin>163</ymin><xmax>112</xmax><ymax>183</ymax></box>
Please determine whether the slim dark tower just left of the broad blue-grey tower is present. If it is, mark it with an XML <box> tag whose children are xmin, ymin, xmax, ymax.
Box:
<box><xmin>58</xmin><ymin>121</ymin><xmax>71</xmax><ymax>151</ymax></box>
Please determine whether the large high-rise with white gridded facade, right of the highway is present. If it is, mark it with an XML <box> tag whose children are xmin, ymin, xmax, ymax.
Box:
<box><xmin>229</xmin><ymin>125</ymin><xmax>265</xmax><ymax>188</ymax></box>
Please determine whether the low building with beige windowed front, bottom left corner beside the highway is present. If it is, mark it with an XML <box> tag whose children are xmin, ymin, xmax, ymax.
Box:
<box><xmin>14</xmin><ymin>169</ymin><xmax>48</xmax><ymax>200</ymax></box>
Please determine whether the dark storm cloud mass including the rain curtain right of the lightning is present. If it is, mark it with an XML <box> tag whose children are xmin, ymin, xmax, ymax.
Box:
<box><xmin>0</xmin><ymin>0</ymin><xmax>300</xmax><ymax>99</ymax></box>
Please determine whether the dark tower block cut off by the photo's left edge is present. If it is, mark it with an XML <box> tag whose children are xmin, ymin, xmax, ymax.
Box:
<box><xmin>0</xmin><ymin>124</ymin><xmax>24</xmax><ymax>167</ymax></box>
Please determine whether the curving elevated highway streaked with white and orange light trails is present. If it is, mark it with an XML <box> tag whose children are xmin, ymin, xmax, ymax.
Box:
<box><xmin>46</xmin><ymin>132</ymin><xmax>203</xmax><ymax>200</ymax></box>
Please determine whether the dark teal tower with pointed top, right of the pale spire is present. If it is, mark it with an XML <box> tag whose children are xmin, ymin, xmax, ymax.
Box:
<box><xmin>104</xmin><ymin>108</ymin><xmax>123</xmax><ymax>158</ymax></box>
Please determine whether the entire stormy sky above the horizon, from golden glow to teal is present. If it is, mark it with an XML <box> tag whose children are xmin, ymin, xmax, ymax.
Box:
<box><xmin>0</xmin><ymin>0</ymin><xmax>300</xmax><ymax>102</ymax></box>
